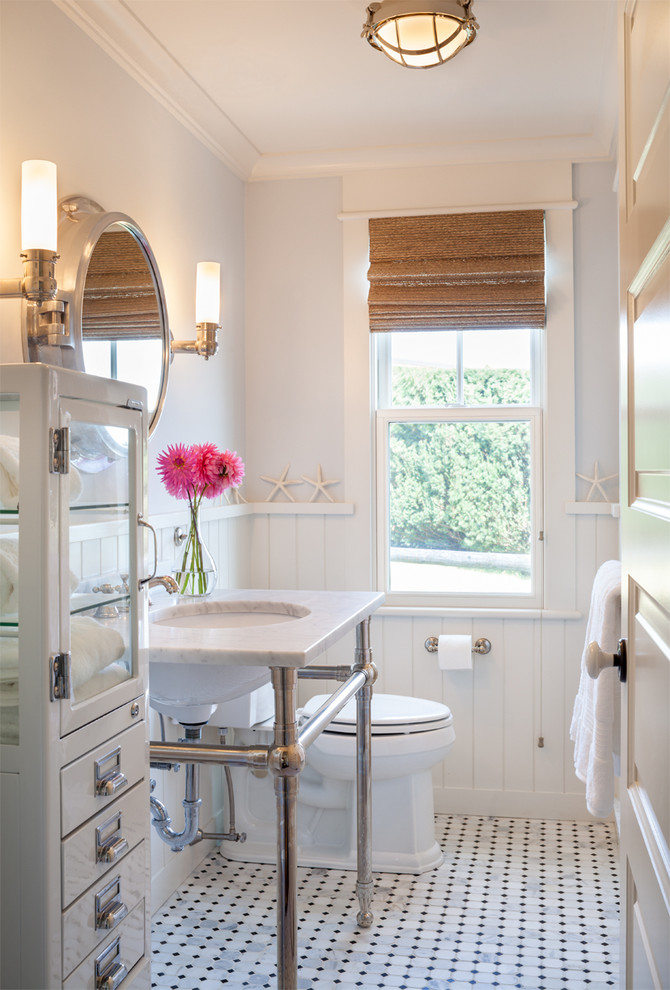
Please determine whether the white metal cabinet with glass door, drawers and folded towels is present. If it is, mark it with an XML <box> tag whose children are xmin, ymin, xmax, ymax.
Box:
<box><xmin>0</xmin><ymin>364</ymin><xmax>151</xmax><ymax>990</ymax></box>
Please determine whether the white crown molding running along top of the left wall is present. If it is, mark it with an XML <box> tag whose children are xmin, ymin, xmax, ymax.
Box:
<box><xmin>52</xmin><ymin>0</ymin><xmax>259</xmax><ymax>179</ymax></box>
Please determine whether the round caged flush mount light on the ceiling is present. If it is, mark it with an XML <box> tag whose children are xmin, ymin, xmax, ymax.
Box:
<box><xmin>362</xmin><ymin>0</ymin><xmax>479</xmax><ymax>69</ymax></box>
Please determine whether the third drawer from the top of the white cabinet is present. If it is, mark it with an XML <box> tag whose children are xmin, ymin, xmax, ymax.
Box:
<box><xmin>63</xmin><ymin>842</ymin><xmax>147</xmax><ymax>976</ymax></box>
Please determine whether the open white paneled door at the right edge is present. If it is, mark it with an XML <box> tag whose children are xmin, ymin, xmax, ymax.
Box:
<box><xmin>619</xmin><ymin>0</ymin><xmax>670</xmax><ymax>990</ymax></box>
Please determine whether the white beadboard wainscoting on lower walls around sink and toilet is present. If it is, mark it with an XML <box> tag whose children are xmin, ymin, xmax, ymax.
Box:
<box><xmin>71</xmin><ymin>503</ymin><xmax>618</xmax><ymax>909</ymax></box>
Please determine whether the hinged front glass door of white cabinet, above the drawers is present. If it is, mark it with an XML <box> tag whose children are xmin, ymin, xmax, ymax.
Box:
<box><xmin>60</xmin><ymin>399</ymin><xmax>143</xmax><ymax>733</ymax></box>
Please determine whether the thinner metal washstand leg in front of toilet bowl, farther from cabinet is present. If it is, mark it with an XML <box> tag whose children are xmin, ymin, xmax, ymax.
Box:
<box><xmin>351</xmin><ymin>616</ymin><xmax>377</xmax><ymax>928</ymax></box>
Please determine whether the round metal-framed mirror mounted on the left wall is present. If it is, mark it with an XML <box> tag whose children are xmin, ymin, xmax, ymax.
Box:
<box><xmin>24</xmin><ymin>196</ymin><xmax>170</xmax><ymax>438</ymax></box>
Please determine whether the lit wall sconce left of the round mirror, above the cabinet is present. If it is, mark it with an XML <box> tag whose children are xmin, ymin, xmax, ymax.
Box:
<box><xmin>0</xmin><ymin>159</ymin><xmax>67</xmax><ymax>344</ymax></box>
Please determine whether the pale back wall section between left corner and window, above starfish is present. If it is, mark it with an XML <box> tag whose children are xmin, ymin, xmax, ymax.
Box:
<box><xmin>245</xmin><ymin>178</ymin><xmax>345</xmax><ymax>501</ymax></box>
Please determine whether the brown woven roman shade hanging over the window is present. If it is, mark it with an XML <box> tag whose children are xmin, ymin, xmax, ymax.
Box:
<box><xmin>368</xmin><ymin>210</ymin><xmax>545</xmax><ymax>332</ymax></box>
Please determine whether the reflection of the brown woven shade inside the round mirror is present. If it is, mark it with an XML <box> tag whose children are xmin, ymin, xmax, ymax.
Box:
<box><xmin>82</xmin><ymin>230</ymin><xmax>162</xmax><ymax>340</ymax></box>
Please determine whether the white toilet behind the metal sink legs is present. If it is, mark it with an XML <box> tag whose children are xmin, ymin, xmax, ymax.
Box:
<box><xmin>210</xmin><ymin>685</ymin><xmax>455</xmax><ymax>874</ymax></box>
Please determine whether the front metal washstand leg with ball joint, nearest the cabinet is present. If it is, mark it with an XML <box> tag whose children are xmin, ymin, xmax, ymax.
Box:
<box><xmin>268</xmin><ymin>667</ymin><xmax>305</xmax><ymax>990</ymax></box>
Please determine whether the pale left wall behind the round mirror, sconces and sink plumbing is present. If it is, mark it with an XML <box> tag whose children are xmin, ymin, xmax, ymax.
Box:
<box><xmin>0</xmin><ymin>0</ymin><xmax>245</xmax><ymax>907</ymax></box>
